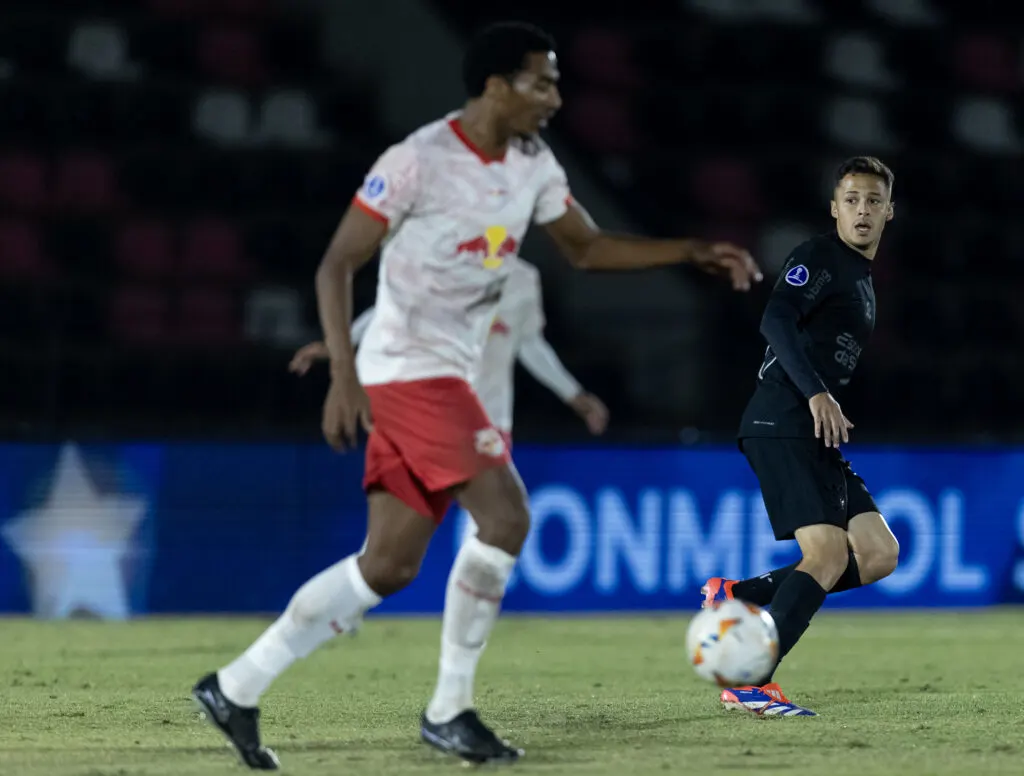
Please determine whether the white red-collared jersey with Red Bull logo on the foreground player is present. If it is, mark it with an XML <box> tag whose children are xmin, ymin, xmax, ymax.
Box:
<box><xmin>354</xmin><ymin>114</ymin><xmax>569</xmax><ymax>385</ymax></box>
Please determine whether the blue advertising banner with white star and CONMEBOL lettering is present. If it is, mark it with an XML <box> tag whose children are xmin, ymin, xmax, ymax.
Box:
<box><xmin>0</xmin><ymin>443</ymin><xmax>1024</xmax><ymax>618</ymax></box>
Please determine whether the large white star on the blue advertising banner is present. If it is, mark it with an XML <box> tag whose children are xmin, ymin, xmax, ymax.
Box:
<box><xmin>2</xmin><ymin>444</ymin><xmax>146</xmax><ymax>619</ymax></box>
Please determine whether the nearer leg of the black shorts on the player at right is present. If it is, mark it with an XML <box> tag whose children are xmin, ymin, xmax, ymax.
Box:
<box><xmin>740</xmin><ymin>437</ymin><xmax>847</xmax><ymax>542</ymax></box>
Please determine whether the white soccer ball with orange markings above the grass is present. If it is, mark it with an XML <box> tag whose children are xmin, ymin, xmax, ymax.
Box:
<box><xmin>686</xmin><ymin>600</ymin><xmax>778</xmax><ymax>687</ymax></box>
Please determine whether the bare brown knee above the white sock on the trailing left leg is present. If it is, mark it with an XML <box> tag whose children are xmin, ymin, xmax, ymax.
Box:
<box><xmin>359</xmin><ymin>489</ymin><xmax>437</xmax><ymax>592</ymax></box>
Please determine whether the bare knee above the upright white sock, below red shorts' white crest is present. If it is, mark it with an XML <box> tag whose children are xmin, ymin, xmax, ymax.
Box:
<box><xmin>452</xmin><ymin>462</ymin><xmax>529</xmax><ymax>555</ymax></box>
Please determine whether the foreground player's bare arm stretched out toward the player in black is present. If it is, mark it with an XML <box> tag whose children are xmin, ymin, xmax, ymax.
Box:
<box><xmin>545</xmin><ymin>201</ymin><xmax>762</xmax><ymax>291</ymax></box>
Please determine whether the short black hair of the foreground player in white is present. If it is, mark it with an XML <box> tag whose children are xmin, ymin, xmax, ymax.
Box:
<box><xmin>462</xmin><ymin>21</ymin><xmax>555</xmax><ymax>97</ymax></box>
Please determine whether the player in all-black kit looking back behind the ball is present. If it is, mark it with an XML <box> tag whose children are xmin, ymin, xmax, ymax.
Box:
<box><xmin>702</xmin><ymin>157</ymin><xmax>899</xmax><ymax>717</ymax></box>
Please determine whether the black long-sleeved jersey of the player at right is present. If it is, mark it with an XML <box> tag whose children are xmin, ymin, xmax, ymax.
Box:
<box><xmin>739</xmin><ymin>232</ymin><xmax>874</xmax><ymax>438</ymax></box>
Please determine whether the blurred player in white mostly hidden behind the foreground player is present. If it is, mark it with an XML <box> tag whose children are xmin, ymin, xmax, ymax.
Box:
<box><xmin>289</xmin><ymin>257</ymin><xmax>608</xmax><ymax>448</ymax></box>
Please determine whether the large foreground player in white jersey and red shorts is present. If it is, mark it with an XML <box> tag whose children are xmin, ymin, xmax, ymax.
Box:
<box><xmin>193</xmin><ymin>23</ymin><xmax>761</xmax><ymax>770</ymax></box>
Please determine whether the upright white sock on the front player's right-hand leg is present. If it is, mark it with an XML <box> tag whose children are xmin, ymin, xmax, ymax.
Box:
<box><xmin>427</xmin><ymin>535</ymin><xmax>516</xmax><ymax>724</ymax></box>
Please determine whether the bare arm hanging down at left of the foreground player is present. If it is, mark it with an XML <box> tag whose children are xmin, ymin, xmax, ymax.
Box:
<box><xmin>316</xmin><ymin>205</ymin><xmax>387</xmax><ymax>449</ymax></box>
